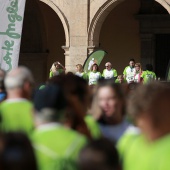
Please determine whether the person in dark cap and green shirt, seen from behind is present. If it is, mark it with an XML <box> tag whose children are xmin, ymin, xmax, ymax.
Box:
<box><xmin>32</xmin><ymin>85</ymin><xmax>86</xmax><ymax>170</ymax></box>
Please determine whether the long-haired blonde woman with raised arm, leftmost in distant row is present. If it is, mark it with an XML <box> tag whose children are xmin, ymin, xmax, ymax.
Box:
<box><xmin>49</xmin><ymin>61</ymin><xmax>66</xmax><ymax>78</ymax></box>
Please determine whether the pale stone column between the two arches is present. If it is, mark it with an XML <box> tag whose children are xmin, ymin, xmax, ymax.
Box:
<box><xmin>65</xmin><ymin>0</ymin><xmax>88</xmax><ymax>72</ymax></box>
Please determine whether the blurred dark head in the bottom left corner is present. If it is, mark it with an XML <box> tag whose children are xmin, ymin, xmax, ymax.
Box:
<box><xmin>0</xmin><ymin>133</ymin><xmax>38</xmax><ymax>170</ymax></box>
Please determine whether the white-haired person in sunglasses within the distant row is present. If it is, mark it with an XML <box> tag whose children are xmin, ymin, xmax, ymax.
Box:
<box><xmin>102</xmin><ymin>62</ymin><xmax>117</xmax><ymax>79</ymax></box>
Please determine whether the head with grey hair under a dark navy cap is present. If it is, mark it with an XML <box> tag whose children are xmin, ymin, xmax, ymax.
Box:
<box><xmin>34</xmin><ymin>85</ymin><xmax>66</xmax><ymax>122</ymax></box>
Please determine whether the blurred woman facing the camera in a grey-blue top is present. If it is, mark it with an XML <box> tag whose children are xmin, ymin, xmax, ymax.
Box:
<box><xmin>92</xmin><ymin>80</ymin><xmax>130</xmax><ymax>142</ymax></box>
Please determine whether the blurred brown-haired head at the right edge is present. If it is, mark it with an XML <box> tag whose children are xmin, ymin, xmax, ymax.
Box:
<box><xmin>127</xmin><ymin>82</ymin><xmax>170</xmax><ymax>131</ymax></box>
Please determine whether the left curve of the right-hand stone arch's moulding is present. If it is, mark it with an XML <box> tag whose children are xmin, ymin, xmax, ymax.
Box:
<box><xmin>88</xmin><ymin>0</ymin><xmax>124</xmax><ymax>47</ymax></box>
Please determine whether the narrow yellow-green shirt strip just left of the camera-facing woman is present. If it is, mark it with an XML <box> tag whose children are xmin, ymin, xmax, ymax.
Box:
<box><xmin>85</xmin><ymin>115</ymin><xmax>101</xmax><ymax>139</ymax></box>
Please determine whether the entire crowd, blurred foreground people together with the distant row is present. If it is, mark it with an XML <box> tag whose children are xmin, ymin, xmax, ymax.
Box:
<box><xmin>0</xmin><ymin>59</ymin><xmax>170</xmax><ymax>170</ymax></box>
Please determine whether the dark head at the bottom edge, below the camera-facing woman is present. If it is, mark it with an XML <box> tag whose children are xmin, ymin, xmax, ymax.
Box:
<box><xmin>78</xmin><ymin>138</ymin><xmax>119</xmax><ymax>170</ymax></box>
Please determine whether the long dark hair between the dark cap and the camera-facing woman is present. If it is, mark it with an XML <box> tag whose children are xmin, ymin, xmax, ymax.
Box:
<box><xmin>48</xmin><ymin>74</ymin><xmax>91</xmax><ymax>137</ymax></box>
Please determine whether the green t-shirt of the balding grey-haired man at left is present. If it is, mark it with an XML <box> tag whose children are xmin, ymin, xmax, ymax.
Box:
<box><xmin>0</xmin><ymin>99</ymin><xmax>34</xmax><ymax>134</ymax></box>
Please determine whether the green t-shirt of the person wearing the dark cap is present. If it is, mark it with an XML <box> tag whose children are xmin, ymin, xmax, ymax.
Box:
<box><xmin>32</xmin><ymin>123</ymin><xmax>87</xmax><ymax>170</ymax></box>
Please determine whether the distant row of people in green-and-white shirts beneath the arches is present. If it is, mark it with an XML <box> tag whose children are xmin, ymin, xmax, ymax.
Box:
<box><xmin>49</xmin><ymin>59</ymin><xmax>156</xmax><ymax>85</ymax></box>
